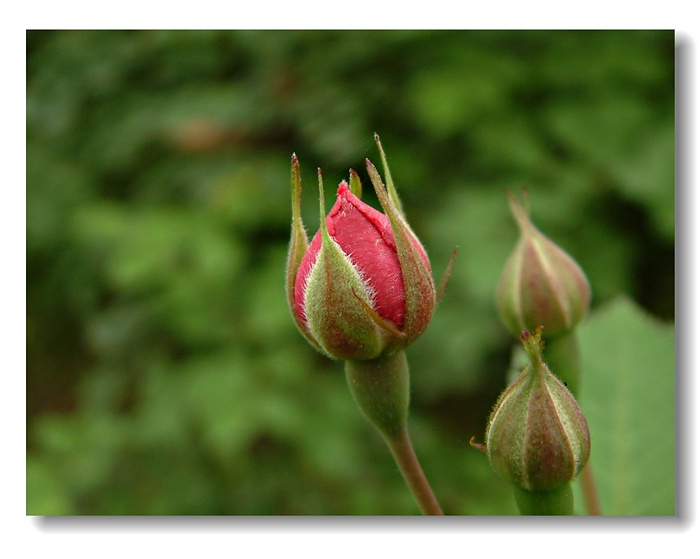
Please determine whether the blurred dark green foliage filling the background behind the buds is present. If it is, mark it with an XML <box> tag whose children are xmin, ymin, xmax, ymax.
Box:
<box><xmin>27</xmin><ymin>31</ymin><xmax>674</xmax><ymax>515</ymax></box>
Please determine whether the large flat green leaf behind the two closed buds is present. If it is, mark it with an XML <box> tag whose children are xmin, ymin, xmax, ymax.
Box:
<box><xmin>576</xmin><ymin>297</ymin><xmax>675</xmax><ymax>516</ymax></box>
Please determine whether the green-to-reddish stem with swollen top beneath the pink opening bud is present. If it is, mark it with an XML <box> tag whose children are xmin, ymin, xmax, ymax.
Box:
<box><xmin>345</xmin><ymin>351</ymin><xmax>443</xmax><ymax>515</ymax></box>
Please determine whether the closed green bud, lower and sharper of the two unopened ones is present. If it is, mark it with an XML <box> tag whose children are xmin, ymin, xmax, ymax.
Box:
<box><xmin>486</xmin><ymin>328</ymin><xmax>591</xmax><ymax>491</ymax></box>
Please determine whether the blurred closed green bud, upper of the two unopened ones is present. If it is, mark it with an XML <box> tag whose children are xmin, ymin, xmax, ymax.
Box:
<box><xmin>496</xmin><ymin>192</ymin><xmax>591</xmax><ymax>336</ymax></box>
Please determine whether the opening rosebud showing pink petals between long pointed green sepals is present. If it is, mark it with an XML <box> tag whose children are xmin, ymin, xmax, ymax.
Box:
<box><xmin>287</xmin><ymin>137</ymin><xmax>436</xmax><ymax>360</ymax></box>
